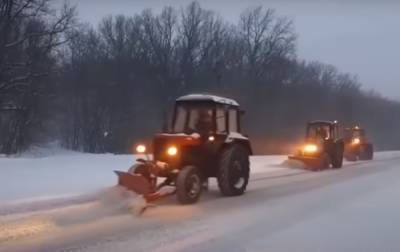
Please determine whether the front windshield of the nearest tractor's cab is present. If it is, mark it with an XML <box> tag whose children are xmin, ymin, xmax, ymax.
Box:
<box><xmin>172</xmin><ymin>102</ymin><xmax>214</xmax><ymax>135</ymax></box>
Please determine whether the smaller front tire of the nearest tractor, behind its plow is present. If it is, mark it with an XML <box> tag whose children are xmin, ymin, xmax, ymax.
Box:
<box><xmin>176</xmin><ymin>166</ymin><xmax>203</xmax><ymax>204</ymax></box>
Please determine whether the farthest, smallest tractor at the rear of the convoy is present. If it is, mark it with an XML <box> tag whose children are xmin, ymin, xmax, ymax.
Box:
<box><xmin>344</xmin><ymin>126</ymin><xmax>374</xmax><ymax>161</ymax></box>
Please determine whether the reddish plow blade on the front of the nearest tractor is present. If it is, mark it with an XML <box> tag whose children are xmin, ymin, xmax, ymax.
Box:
<box><xmin>114</xmin><ymin>171</ymin><xmax>154</xmax><ymax>196</ymax></box>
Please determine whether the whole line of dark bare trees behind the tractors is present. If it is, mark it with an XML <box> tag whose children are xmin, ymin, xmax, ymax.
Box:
<box><xmin>0</xmin><ymin>0</ymin><xmax>400</xmax><ymax>154</ymax></box>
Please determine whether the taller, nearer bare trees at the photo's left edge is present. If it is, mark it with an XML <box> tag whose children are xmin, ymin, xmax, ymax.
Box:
<box><xmin>0</xmin><ymin>0</ymin><xmax>74</xmax><ymax>153</ymax></box>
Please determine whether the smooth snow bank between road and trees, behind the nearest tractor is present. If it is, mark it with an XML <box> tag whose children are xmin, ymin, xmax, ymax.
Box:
<box><xmin>0</xmin><ymin>151</ymin><xmax>286</xmax><ymax>205</ymax></box>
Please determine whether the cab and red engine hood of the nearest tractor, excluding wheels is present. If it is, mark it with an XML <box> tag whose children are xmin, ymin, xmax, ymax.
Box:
<box><xmin>153</xmin><ymin>95</ymin><xmax>251</xmax><ymax>171</ymax></box>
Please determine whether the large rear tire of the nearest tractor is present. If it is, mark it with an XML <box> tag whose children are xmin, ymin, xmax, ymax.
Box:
<box><xmin>217</xmin><ymin>145</ymin><xmax>250</xmax><ymax>196</ymax></box>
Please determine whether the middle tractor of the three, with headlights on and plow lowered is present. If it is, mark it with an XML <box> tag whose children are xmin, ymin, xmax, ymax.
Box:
<box><xmin>289</xmin><ymin>121</ymin><xmax>344</xmax><ymax>170</ymax></box>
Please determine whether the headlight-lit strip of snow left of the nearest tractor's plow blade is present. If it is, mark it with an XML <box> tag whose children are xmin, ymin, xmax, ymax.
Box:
<box><xmin>0</xmin><ymin>187</ymin><xmax>144</xmax><ymax>245</ymax></box>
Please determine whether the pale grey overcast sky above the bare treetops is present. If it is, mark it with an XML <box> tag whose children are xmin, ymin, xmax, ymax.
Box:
<box><xmin>62</xmin><ymin>0</ymin><xmax>400</xmax><ymax>100</ymax></box>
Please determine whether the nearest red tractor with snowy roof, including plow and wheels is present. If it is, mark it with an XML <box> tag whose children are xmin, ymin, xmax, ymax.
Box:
<box><xmin>116</xmin><ymin>94</ymin><xmax>252</xmax><ymax>204</ymax></box>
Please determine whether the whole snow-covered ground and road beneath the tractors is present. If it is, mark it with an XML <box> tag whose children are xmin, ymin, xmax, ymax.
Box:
<box><xmin>0</xmin><ymin>152</ymin><xmax>400</xmax><ymax>251</ymax></box>
